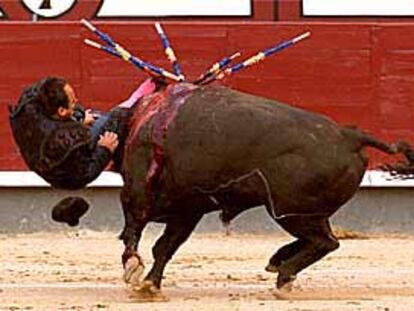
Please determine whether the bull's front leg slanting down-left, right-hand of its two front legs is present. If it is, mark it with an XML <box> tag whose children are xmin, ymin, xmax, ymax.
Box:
<box><xmin>138</xmin><ymin>214</ymin><xmax>203</xmax><ymax>293</ymax></box>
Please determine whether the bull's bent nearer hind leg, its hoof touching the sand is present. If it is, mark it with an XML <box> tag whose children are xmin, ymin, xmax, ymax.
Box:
<box><xmin>276</xmin><ymin>216</ymin><xmax>339</xmax><ymax>289</ymax></box>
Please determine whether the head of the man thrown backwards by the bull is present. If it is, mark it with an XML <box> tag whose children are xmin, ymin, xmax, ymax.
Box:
<box><xmin>39</xmin><ymin>77</ymin><xmax>78</xmax><ymax>120</ymax></box>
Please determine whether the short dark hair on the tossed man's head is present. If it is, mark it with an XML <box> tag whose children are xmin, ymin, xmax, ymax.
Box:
<box><xmin>38</xmin><ymin>77</ymin><xmax>69</xmax><ymax>116</ymax></box>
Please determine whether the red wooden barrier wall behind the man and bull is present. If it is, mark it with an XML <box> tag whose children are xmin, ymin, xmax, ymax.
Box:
<box><xmin>0</xmin><ymin>21</ymin><xmax>414</xmax><ymax>170</ymax></box>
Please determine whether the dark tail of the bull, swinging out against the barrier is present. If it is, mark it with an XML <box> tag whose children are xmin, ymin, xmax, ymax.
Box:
<box><xmin>342</xmin><ymin>127</ymin><xmax>414</xmax><ymax>179</ymax></box>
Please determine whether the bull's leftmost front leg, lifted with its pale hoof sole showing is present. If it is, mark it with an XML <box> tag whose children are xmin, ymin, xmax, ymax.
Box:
<box><xmin>120</xmin><ymin>188</ymin><xmax>148</xmax><ymax>286</ymax></box>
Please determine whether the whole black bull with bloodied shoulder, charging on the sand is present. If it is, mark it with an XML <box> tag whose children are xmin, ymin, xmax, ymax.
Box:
<box><xmin>8</xmin><ymin>83</ymin><xmax>414</xmax><ymax>292</ymax></box>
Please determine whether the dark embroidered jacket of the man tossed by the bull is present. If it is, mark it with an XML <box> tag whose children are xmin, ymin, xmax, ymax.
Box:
<box><xmin>10</xmin><ymin>85</ymin><xmax>129</xmax><ymax>189</ymax></box>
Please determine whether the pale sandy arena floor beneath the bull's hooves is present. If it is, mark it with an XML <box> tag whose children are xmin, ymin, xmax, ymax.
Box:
<box><xmin>0</xmin><ymin>231</ymin><xmax>414</xmax><ymax>311</ymax></box>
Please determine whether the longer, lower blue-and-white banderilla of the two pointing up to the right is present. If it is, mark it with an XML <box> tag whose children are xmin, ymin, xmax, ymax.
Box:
<box><xmin>210</xmin><ymin>31</ymin><xmax>310</xmax><ymax>82</ymax></box>
